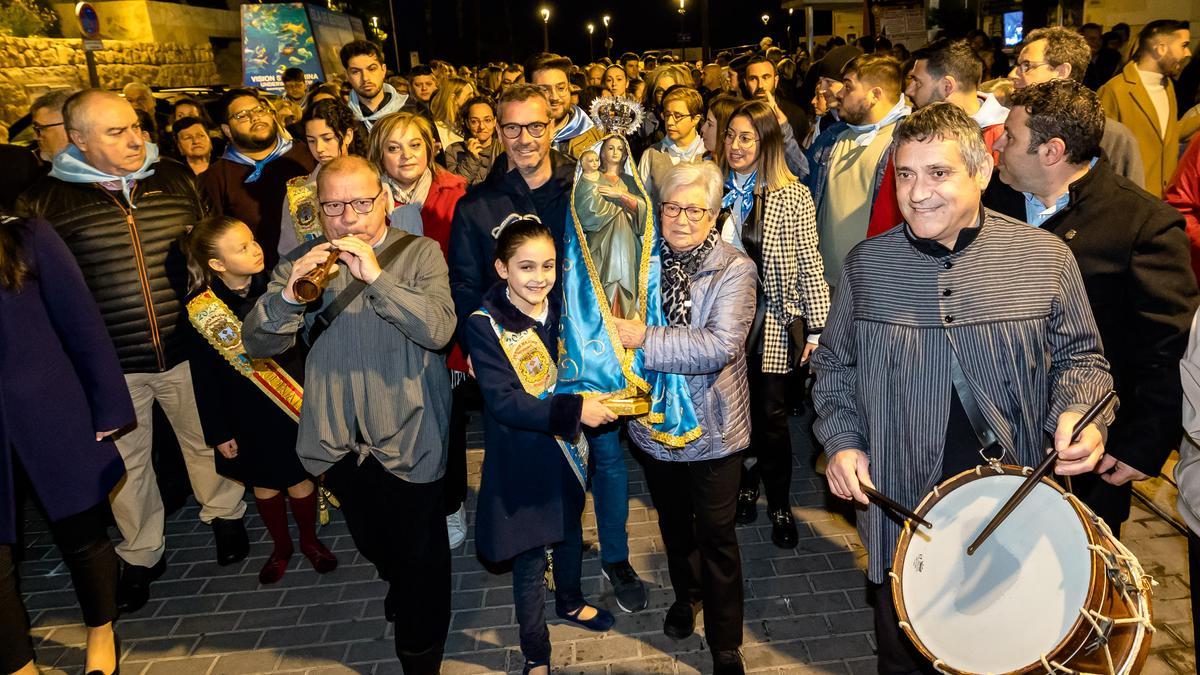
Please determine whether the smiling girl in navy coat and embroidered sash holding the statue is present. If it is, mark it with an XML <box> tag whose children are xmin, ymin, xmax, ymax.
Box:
<box><xmin>464</xmin><ymin>215</ymin><xmax>617</xmax><ymax>675</ymax></box>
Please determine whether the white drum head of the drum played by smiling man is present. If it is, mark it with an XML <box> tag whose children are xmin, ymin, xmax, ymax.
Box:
<box><xmin>901</xmin><ymin>476</ymin><xmax>1092</xmax><ymax>673</ymax></box>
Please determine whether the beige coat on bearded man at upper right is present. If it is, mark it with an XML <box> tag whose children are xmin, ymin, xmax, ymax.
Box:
<box><xmin>1100</xmin><ymin>61</ymin><xmax>1180</xmax><ymax>197</ymax></box>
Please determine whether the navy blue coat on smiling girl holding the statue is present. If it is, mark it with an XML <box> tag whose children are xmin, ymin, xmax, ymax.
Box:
<box><xmin>466</xmin><ymin>283</ymin><xmax>583</xmax><ymax>562</ymax></box>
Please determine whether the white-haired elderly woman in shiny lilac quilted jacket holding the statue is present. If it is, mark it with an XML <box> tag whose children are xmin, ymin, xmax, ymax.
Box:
<box><xmin>617</xmin><ymin>162</ymin><xmax>758</xmax><ymax>675</ymax></box>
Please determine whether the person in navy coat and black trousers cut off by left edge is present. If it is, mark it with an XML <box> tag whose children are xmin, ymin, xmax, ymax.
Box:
<box><xmin>0</xmin><ymin>219</ymin><xmax>134</xmax><ymax>675</ymax></box>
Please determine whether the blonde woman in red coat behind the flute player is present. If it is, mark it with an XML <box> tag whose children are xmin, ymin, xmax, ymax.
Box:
<box><xmin>367</xmin><ymin>113</ymin><xmax>472</xmax><ymax>549</ymax></box>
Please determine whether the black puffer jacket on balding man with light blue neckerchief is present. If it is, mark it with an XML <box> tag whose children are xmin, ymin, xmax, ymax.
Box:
<box><xmin>18</xmin><ymin>157</ymin><xmax>209</xmax><ymax>372</ymax></box>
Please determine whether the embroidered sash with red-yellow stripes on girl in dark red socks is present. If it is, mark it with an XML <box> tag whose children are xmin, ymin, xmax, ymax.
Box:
<box><xmin>187</xmin><ymin>289</ymin><xmax>304</xmax><ymax>422</ymax></box>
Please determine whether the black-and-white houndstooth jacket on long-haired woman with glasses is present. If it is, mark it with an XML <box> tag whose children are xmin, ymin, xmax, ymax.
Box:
<box><xmin>760</xmin><ymin>180</ymin><xmax>829</xmax><ymax>375</ymax></box>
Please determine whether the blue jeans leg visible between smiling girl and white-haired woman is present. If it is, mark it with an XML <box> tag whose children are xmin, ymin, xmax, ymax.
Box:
<box><xmin>587</xmin><ymin>424</ymin><xmax>629</xmax><ymax>563</ymax></box>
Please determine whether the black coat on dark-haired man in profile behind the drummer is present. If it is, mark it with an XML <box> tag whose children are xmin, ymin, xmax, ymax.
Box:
<box><xmin>983</xmin><ymin>159</ymin><xmax>1200</xmax><ymax>476</ymax></box>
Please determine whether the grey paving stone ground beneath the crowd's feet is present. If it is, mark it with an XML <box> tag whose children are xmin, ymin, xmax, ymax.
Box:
<box><xmin>14</xmin><ymin>416</ymin><xmax>1196</xmax><ymax>675</ymax></box>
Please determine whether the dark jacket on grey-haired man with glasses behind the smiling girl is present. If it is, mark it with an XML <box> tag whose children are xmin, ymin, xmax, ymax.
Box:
<box><xmin>449</xmin><ymin>150</ymin><xmax>575</xmax><ymax>348</ymax></box>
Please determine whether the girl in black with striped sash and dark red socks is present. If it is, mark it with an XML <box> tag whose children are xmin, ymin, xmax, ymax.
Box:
<box><xmin>184</xmin><ymin>216</ymin><xmax>337</xmax><ymax>584</ymax></box>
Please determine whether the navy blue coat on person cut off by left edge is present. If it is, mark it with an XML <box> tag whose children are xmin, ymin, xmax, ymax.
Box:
<box><xmin>0</xmin><ymin>220</ymin><xmax>134</xmax><ymax>544</ymax></box>
